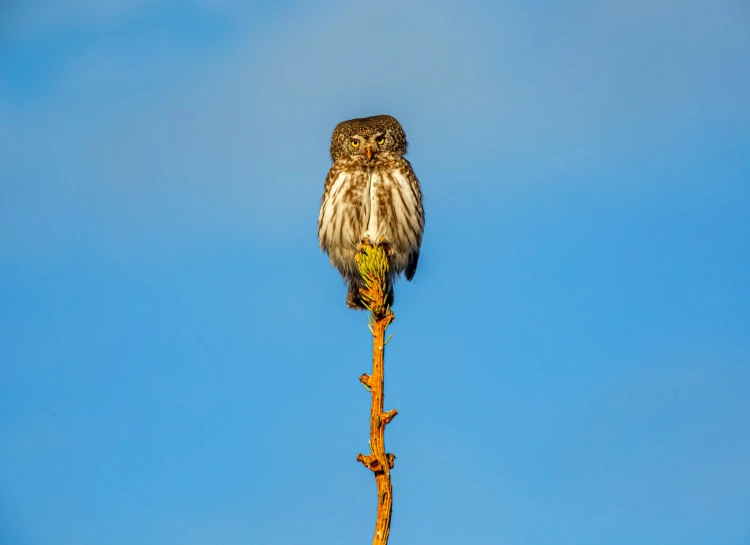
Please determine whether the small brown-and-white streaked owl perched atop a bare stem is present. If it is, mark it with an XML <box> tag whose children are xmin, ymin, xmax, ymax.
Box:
<box><xmin>318</xmin><ymin>115</ymin><xmax>424</xmax><ymax>309</ymax></box>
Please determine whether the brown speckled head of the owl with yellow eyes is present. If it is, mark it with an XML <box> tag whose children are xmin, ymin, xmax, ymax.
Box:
<box><xmin>331</xmin><ymin>115</ymin><xmax>406</xmax><ymax>163</ymax></box>
